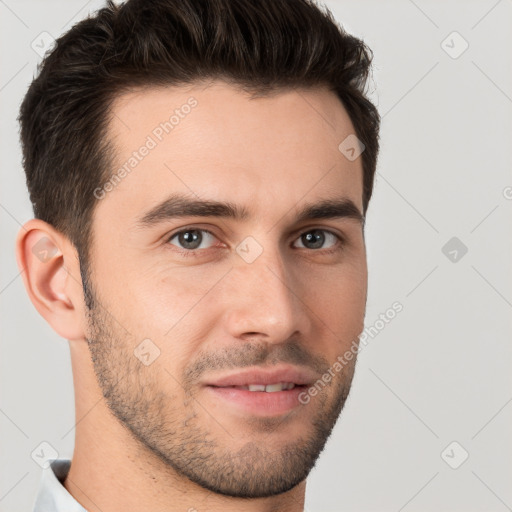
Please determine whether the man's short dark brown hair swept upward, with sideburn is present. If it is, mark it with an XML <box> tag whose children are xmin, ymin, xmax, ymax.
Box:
<box><xmin>19</xmin><ymin>0</ymin><xmax>380</xmax><ymax>304</ymax></box>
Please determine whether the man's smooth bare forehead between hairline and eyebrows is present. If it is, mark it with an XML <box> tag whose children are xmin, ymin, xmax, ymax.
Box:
<box><xmin>97</xmin><ymin>81</ymin><xmax>362</xmax><ymax>230</ymax></box>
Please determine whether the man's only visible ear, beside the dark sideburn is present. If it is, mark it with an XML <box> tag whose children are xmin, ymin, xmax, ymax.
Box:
<box><xmin>16</xmin><ymin>219</ymin><xmax>86</xmax><ymax>340</ymax></box>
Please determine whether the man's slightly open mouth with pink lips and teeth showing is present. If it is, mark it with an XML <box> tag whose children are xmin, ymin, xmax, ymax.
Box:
<box><xmin>205</xmin><ymin>367</ymin><xmax>316</xmax><ymax>417</ymax></box>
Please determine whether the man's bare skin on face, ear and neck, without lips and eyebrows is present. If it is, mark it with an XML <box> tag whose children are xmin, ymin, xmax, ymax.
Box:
<box><xmin>17</xmin><ymin>81</ymin><xmax>367</xmax><ymax>512</ymax></box>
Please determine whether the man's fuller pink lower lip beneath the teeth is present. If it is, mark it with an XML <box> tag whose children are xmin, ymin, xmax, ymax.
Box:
<box><xmin>206</xmin><ymin>386</ymin><xmax>307</xmax><ymax>416</ymax></box>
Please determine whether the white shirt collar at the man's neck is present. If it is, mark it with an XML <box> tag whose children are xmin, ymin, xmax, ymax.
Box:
<box><xmin>32</xmin><ymin>459</ymin><xmax>87</xmax><ymax>512</ymax></box>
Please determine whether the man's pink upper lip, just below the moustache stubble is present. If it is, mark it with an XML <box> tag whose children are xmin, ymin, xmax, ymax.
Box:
<box><xmin>205</xmin><ymin>366</ymin><xmax>316</xmax><ymax>387</ymax></box>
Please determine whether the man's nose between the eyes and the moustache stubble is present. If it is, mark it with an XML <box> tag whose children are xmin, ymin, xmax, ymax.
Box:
<box><xmin>224</xmin><ymin>243</ymin><xmax>311</xmax><ymax>343</ymax></box>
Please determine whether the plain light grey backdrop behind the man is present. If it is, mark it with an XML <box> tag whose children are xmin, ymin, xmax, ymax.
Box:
<box><xmin>0</xmin><ymin>0</ymin><xmax>512</xmax><ymax>512</ymax></box>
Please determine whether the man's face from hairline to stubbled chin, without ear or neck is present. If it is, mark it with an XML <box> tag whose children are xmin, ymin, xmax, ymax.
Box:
<box><xmin>87</xmin><ymin>82</ymin><xmax>367</xmax><ymax>497</ymax></box>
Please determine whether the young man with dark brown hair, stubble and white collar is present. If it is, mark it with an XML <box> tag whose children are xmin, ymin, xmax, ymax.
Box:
<box><xmin>17</xmin><ymin>0</ymin><xmax>379</xmax><ymax>512</ymax></box>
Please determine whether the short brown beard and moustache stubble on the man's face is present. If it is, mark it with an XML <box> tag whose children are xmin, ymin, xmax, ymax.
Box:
<box><xmin>83</xmin><ymin>281</ymin><xmax>355</xmax><ymax>498</ymax></box>
